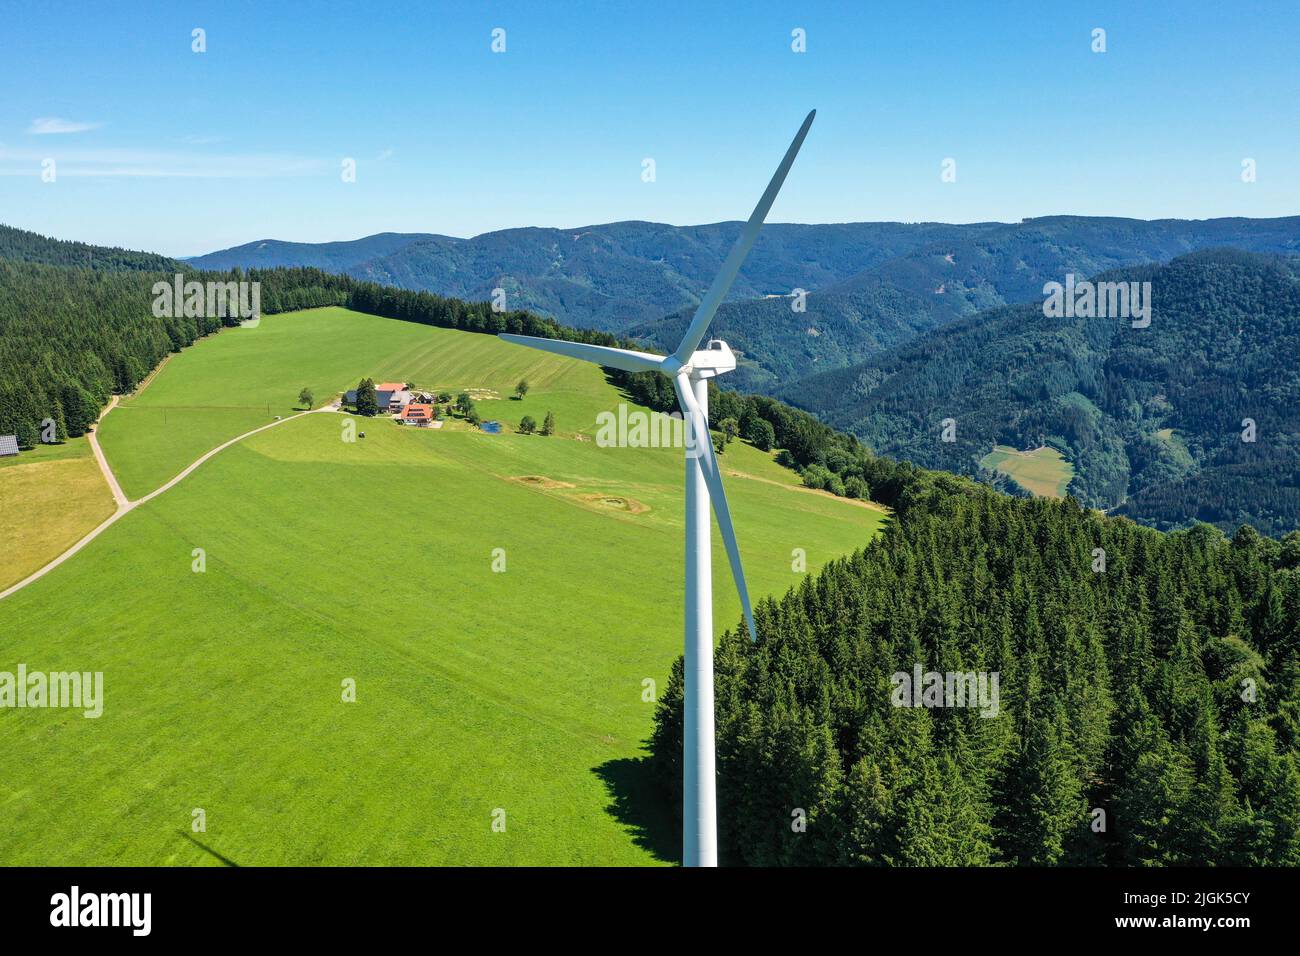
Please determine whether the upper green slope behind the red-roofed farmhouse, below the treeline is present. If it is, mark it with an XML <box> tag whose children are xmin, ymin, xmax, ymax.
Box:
<box><xmin>100</xmin><ymin>308</ymin><xmax>626</xmax><ymax>498</ymax></box>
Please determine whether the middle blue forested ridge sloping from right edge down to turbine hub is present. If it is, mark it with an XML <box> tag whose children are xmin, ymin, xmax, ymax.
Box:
<box><xmin>627</xmin><ymin>216</ymin><xmax>1300</xmax><ymax>394</ymax></box>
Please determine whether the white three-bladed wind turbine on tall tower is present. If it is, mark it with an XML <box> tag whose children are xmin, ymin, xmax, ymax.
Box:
<box><xmin>499</xmin><ymin>109</ymin><xmax>816</xmax><ymax>866</ymax></box>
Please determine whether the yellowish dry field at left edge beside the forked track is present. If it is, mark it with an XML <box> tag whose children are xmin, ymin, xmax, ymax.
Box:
<box><xmin>0</xmin><ymin>438</ymin><xmax>114</xmax><ymax>590</ymax></box>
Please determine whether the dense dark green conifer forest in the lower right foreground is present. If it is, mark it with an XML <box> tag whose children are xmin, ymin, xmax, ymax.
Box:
<box><xmin>651</xmin><ymin>472</ymin><xmax>1300</xmax><ymax>866</ymax></box>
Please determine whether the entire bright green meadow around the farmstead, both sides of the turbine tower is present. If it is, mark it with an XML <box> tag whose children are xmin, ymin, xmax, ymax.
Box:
<box><xmin>0</xmin><ymin>308</ymin><xmax>883</xmax><ymax>865</ymax></box>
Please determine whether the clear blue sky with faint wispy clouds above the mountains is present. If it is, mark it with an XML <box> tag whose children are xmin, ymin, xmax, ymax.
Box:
<box><xmin>0</xmin><ymin>0</ymin><xmax>1300</xmax><ymax>255</ymax></box>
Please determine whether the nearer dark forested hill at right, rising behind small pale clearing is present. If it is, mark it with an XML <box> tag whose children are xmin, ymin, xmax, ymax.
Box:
<box><xmin>779</xmin><ymin>250</ymin><xmax>1300</xmax><ymax>535</ymax></box>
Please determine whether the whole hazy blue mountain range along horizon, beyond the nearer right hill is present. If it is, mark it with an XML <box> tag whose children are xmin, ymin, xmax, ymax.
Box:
<box><xmin>190</xmin><ymin>216</ymin><xmax>1300</xmax><ymax>366</ymax></box>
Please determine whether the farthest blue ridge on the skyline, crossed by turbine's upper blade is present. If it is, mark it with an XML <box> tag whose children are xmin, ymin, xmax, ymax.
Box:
<box><xmin>190</xmin><ymin>221</ymin><xmax>965</xmax><ymax>332</ymax></box>
